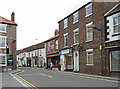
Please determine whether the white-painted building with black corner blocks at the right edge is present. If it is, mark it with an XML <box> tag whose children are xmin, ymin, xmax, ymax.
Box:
<box><xmin>105</xmin><ymin>2</ymin><xmax>120</xmax><ymax>75</ymax></box>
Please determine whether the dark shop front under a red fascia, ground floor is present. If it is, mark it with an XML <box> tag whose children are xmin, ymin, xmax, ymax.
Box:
<box><xmin>47</xmin><ymin>53</ymin><xmax>60</xmax><ymax>69</ymax></box>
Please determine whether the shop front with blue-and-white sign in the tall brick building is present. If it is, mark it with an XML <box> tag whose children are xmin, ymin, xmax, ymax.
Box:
<box><xmin>59</xmin><ymin>49</ymin><xmax>73</xmax><ymax>71</ymax></box>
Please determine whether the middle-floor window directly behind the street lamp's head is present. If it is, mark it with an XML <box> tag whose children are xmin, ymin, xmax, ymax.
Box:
<box><xmin>86</xmin><ymin>22</ymin><xmax>93</xmax><ymax>41</ymax></box>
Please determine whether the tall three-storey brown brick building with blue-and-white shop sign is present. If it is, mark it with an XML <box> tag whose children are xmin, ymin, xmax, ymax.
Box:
<box><xmin>58</xmin><ymin>1</ymin><xmax>118</xmax><ymax>75</ymax></box>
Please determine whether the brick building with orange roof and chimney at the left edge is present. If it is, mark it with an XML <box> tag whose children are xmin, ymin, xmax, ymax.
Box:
<box><xmin>0</xmin><ymin>12</ymin><xmax>17</xmax><ymax>69</ymax></box>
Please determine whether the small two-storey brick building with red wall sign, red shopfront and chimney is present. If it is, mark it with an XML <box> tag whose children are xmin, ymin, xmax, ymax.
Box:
<box><xmin>45</xmin><ymin>29</ymin><xmax>60</xmax><ymax>68</ymax></box>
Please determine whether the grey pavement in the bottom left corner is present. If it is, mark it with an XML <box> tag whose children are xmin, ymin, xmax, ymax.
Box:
<box><xmin>1</xmin><ymin>70</ymin><xmax>27</xmax><ymax>89</ymax></box>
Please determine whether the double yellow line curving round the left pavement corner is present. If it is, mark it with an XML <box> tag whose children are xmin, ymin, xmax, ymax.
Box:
<box><xmin>13</xmin><ymin>70</ymin><xmax>38</xmax><ymax>89</ymax></box>
